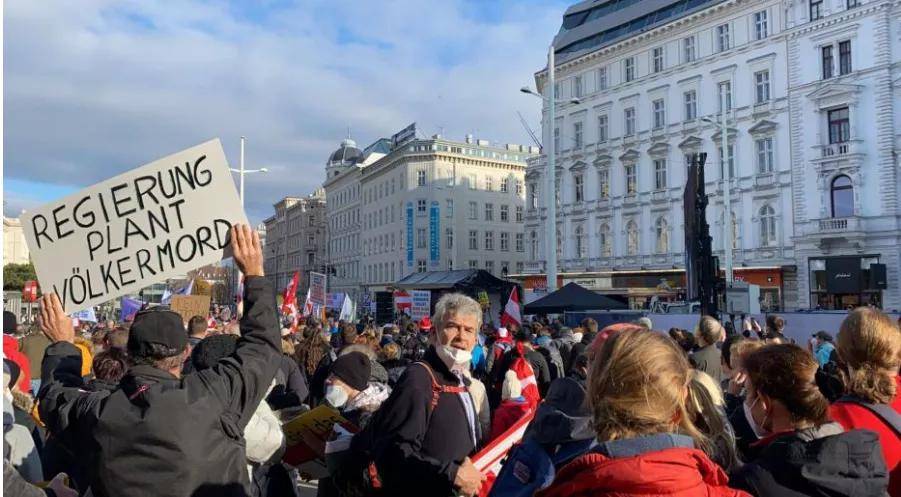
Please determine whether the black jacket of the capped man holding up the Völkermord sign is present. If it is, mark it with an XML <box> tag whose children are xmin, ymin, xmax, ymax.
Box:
<box><xmin>39</xmin><ymin>277</ymin><xmax>282</xmax><ymax>497</ymax></box>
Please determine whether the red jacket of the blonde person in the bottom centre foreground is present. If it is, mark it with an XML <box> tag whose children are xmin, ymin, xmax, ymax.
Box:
<box><xmin>535</xmin><ymin>448</ymin><xmax>750</xmax><ymax>497</ymax></box>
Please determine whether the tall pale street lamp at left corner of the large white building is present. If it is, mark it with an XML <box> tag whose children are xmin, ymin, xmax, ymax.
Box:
<box><xmin>519</xmin><ymin>43</ymin><xmax>582</xmax><ymax>293</ymax></box>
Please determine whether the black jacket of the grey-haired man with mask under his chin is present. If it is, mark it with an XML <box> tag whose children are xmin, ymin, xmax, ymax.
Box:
<box><xmin>351</xmin><ymin>347</ymin><xmax>475</xmax><ymax>497</ymax></box>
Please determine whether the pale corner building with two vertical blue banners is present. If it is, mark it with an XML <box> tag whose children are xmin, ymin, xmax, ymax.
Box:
<box><xmin>325</xmin><ymin>128</ymin><xmax>537</xmax><ymax>296</ymax></box>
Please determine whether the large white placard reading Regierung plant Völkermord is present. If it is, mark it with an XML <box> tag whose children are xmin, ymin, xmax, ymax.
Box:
<box><xmin>22</xmin><ymin>139</ymin><xmax>247</xmax><ymax>313</ymax></box>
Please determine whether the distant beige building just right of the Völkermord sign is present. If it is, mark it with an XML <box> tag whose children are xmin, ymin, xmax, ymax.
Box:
<box><xmin>263</xmin><ymin>189</ymin><xmax>327</xmax><ymax>298</ymax></box>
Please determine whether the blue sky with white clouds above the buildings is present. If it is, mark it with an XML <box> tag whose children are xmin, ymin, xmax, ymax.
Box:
<box><xmin>3</xmin><ymin>0</ymin><xmax>570</xmax><ymax>221</ymax></box>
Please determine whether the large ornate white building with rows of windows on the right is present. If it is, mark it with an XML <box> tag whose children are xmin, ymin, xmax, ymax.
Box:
<box><xmin>523</xmin><ymin>0</ymin><xmax>901</xmax><ymax>309</ymax></box>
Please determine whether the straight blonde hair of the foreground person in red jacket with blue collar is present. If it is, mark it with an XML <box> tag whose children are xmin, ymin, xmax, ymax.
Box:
<box><xmin>588</xmin><ymin>328</ymin><xmax>709</xmax><ymax>447</ymax></box>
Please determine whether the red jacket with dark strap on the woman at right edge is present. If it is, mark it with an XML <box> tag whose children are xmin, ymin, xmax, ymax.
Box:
<box><xmin>829</xmin><ymin>376</ymin><xmax>901</xmax><ymax>496</ymax></box>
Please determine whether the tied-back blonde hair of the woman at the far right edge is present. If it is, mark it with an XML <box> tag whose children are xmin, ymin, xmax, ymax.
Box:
<box><xmin>835</xmin><ymin>307</ymin><xmax>901</xmax><ymax>404</ymax></box>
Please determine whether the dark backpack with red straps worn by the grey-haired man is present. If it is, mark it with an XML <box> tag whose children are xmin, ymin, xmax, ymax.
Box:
<box><xmin>330</xmin><ymin>361</ymin><xmax>467</xmax><ymax>497</ymax></box>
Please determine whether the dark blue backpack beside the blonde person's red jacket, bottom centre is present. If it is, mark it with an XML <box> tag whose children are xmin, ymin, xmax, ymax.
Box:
<box><xmin>488</xmin><ymin>437</ymin><xmax>593</xmax><ymax>497</ymax></box>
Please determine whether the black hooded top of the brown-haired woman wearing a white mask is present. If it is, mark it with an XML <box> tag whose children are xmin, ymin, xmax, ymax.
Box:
<box><xmin>729</xmin><ymin>423</ymin><xmax>888</xmax><ymax>497</ymax></box>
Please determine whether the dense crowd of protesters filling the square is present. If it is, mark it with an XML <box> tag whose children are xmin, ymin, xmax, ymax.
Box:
<box><xmin>3</xmin><ymin>226</ymin><xmax>901</xmax><ymax>497</ymax></box>
